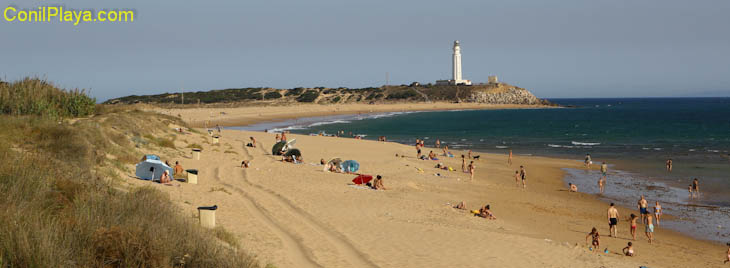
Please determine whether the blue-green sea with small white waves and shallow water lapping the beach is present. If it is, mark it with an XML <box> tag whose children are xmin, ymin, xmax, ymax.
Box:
<box><xmin>233</xmin><ymin>98</ymin><xmax>730</xmax><ymax>243</ymax></box>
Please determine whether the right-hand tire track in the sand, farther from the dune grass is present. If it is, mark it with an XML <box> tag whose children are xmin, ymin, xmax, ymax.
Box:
<box><xmin>239</xmin><ymin>139</ymin><xmax>377</xmax><ymax>267</ymax></box>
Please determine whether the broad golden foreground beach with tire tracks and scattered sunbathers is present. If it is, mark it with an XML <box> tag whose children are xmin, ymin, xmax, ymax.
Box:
<box><xmin>129</xmin><ymin>112</ymin><xmax>726</xmax><ymax>267</ymax></box>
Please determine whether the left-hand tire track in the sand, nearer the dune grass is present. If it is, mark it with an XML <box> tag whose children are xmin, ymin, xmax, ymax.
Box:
<box><xmin>214</xmin><ymin>167</ymin><xmax>322</xmax><ymax>267</ymax></box>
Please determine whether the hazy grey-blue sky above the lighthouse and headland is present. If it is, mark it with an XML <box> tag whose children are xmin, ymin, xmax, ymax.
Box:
<box><xmin>0</xmin><ymin>0</ymin><xmax>730</xmax><ymax>101</ymax></box>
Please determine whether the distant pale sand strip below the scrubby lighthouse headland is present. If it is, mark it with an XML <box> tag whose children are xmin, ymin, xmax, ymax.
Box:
<box><xmin>146</xmin><ymin>102</ymin><xmax>554</xmax><ymax>127</ymax></box>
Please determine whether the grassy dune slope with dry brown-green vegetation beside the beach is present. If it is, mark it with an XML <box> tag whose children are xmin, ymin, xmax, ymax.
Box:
<box><xmin>0</xmin><ymin>78</ymin><xmax>259</xmax><ymax>267</ymax></box>
